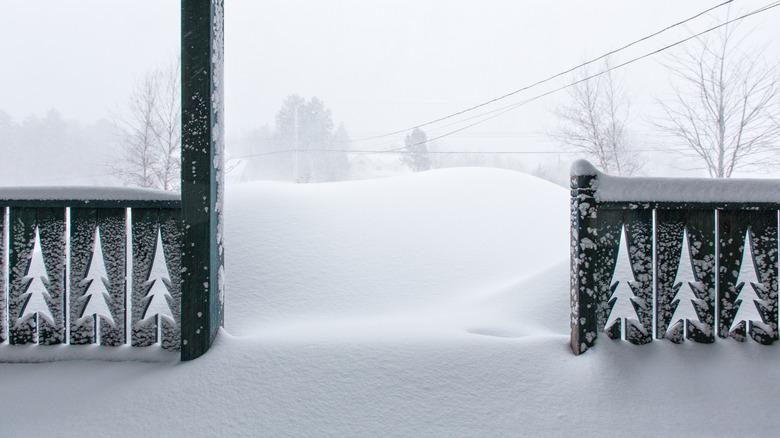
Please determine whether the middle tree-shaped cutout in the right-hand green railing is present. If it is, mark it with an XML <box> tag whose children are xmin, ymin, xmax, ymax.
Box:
<box><xmin>666</xmin><ymin>229</ymin><xmax>707</xmax><ymax>342</ymax></box>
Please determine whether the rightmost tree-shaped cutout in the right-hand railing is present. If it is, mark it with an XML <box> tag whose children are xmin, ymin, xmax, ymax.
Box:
<box><xmin>729</xmin><ymin>229</ymin><xmax>772</xmax><ymax>340</ymax></box>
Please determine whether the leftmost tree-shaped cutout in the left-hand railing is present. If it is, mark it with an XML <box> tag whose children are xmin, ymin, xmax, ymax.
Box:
<box><xmin>16</xmin><ymin>227</ymin><xmax>54</xmax><ymax>325</ymax></box>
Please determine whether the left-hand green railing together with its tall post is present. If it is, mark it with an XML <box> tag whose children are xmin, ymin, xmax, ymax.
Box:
<box><xmin>0</xmin><ymin>0</ymin><xmax>225</xmax><ymax>361</ymax></box>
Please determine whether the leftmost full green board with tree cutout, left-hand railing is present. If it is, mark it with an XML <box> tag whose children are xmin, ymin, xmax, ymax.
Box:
<box><xmin>8</xmin><ymin>208</ymin><xmax>65</xmax><ymax>345</ymax></box>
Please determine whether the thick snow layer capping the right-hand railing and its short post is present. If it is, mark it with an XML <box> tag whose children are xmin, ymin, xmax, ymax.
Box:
<box><xmin>571</xmin><ymin>160</ymin><xmax>780</xmax><ymax>203</ymax></box>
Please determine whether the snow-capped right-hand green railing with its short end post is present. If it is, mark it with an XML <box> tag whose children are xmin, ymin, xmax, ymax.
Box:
<box><xmin>571</xmin><ymin>161</ymin><xmax>780</xmax><ymax>354</ymax></box>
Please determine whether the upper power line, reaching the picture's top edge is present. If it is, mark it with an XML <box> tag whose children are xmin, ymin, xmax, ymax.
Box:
<box><xmin>353</xmin><ymin>0</ymin><xmax>734</xmax><ymax>142</ymax></box>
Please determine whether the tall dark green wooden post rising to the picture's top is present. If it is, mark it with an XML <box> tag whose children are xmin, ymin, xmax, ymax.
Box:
<box><xmin>181</xmin><ymin>0</ymin><xmax>224</xmax><ymax>360</ymax></box>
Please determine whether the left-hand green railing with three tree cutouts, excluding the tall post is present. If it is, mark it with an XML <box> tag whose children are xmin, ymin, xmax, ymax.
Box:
<box><xmin>0</xmin><ymin>187</ymin><xmax>181</xmax><ymax>351</ymax></box>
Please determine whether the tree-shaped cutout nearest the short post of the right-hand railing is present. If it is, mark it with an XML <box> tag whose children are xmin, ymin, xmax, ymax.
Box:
<box><xmin>604</xmin><ymin>225</ymin><xmax>642</xmax><ymax>339</ymax></box>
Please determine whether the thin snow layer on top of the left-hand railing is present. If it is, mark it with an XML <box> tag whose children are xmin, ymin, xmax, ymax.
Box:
<box><xmin>0</xmin><ymin>186</ymin><xmax>181</xmax><ymax>201</ymax></box>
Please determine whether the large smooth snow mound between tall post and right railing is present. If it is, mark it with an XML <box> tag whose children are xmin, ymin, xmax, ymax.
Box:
<box><xmin>226</xmin><ymin>168</ymin><xmax>569</xmax><ymax>336</ymax></box>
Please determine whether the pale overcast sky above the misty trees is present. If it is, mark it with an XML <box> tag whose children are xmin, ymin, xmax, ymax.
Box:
<box><xmin>0</xmin><ymin>0</ymin><xmax>780</xmax><ymax>176</ymax></box>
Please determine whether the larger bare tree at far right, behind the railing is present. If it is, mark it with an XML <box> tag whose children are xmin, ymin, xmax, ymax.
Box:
<box><xmin>656</xmin><ymin>22</ymin><xmax>780</xmax><ymax>178</ymax></box>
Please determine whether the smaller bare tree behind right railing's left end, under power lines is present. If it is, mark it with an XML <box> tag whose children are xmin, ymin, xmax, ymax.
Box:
<box><xmin>552</xmin><ymin>61</ymin><xmax>640</xmax><ymax>175</ymax></box>
